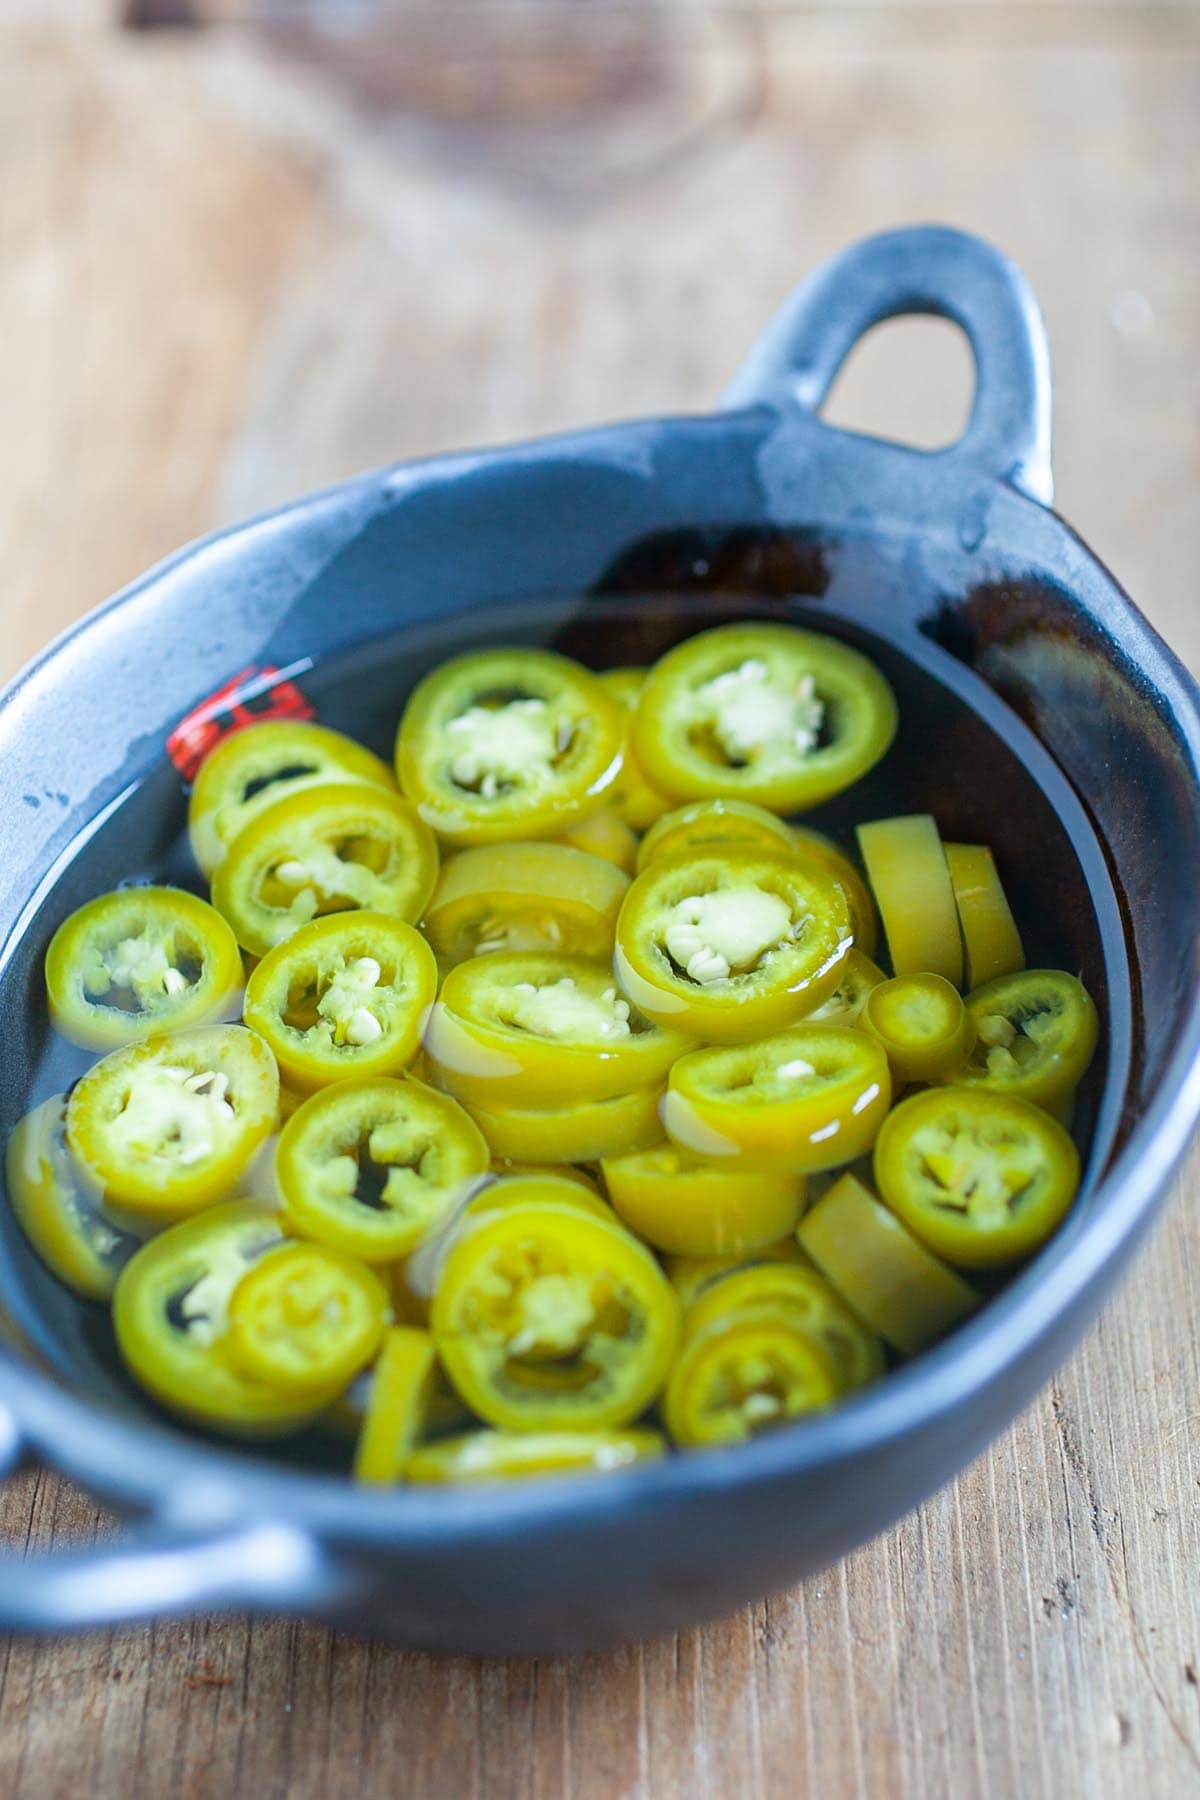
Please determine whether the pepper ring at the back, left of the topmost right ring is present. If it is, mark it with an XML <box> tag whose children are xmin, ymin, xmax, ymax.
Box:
<box><xmin>396</xmin><ymin>650</ymin><xmax>624</xmax><ymax>844</ymax></box>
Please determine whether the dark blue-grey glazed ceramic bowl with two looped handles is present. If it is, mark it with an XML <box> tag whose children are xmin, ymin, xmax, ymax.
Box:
<box><xmin>0</xmin><ymin>229</ymin><xmax>1200</xmax><ymax>1651</ymax></box>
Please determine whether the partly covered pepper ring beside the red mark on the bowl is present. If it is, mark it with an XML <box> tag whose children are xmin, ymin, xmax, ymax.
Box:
<box><xmin>187</xmin><ymin>718</ymin><xmax>396</xmax><ymax>877</ymax></box>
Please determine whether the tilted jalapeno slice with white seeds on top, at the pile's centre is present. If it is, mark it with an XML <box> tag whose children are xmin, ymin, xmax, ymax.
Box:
<box><xmin>425</xmin><ymin>952</ymin><xmax>691</xmax><ymax>1109</ymax></box>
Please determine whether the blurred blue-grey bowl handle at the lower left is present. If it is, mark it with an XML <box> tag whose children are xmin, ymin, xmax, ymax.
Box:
<box><xmin>0</xmin><ymin>1413</ymin><xmax>338</xmax><ymax>1633</ymax></box>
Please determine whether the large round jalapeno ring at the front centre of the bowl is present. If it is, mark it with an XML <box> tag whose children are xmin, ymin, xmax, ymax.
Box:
<box><xmin>432</xmin><ymin>1201</ymin><xmax>680</xmax><ymax>1431</ymax></box>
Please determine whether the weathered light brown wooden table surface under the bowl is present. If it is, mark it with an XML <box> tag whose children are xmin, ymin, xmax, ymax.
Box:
<box><xmin>0</xmin><ymin>0</ymin><xmax>1200</xmax><ymax>1800</ymax></box>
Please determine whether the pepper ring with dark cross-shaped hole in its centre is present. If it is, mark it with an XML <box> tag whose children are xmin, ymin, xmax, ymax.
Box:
<box><xmin>275</xmin><ymin>1076</ymin><xmax>489</xmax><ymax>1264</ymax></box>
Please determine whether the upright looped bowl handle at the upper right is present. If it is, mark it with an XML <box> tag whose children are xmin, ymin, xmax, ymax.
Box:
<box><xmin>723</xmin><ymin>225</ymin><xmax>1054</xmax><ymax>506</ymax></box>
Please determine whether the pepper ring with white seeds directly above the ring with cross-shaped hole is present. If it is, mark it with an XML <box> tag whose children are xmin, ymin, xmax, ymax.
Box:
<box><xmin>245</xmin><ymin>913</ymin><xmax>437</xmax><ymax>1093</ymax></box>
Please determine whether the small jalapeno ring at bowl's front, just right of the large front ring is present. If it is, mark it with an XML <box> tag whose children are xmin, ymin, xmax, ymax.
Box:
<box><xmin>662</xmin><ymin>1307</ymin><xmax>840</xmax><ymax>1447</ymax></box>
